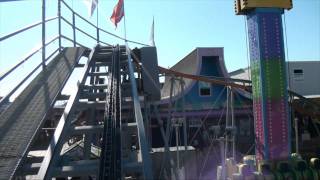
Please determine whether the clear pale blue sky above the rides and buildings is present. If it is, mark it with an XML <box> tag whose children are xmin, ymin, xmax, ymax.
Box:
<box><xmin>0</xmin><ymin>0</ymin><xmax>320</xmax><ymax>97</ymax></box>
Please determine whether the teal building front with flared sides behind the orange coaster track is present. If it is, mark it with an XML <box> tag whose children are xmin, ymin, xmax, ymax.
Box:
<box><xmin>162</xmin><ymin>48</ymin><xmax>251</xmax><ymax>113</ymax></box>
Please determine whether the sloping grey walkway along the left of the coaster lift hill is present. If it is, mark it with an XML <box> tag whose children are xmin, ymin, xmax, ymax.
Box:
<box><xmin>0</xmin><ymin>48</ymin><xmax>86</xmax><ymax>179</ymax></box>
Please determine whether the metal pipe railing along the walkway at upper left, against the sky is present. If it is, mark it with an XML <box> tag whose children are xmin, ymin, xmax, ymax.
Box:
<box><xmin>0</xmin><ymin>0</ymin><xmax>149</xmax><ymax>107</ymax></box>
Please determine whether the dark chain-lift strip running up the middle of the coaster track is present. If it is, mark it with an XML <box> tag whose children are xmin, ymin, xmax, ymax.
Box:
<box><xmin>99</xmin><ymin>46</ymin><xmax>121</xmax><ymax>180</ymax></box>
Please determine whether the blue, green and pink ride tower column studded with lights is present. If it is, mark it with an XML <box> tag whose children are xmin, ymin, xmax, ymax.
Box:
<box><xmin>247</xmin><ymin>8</ymin><xmax>291</xmax><ymax>160</ymax></box>
